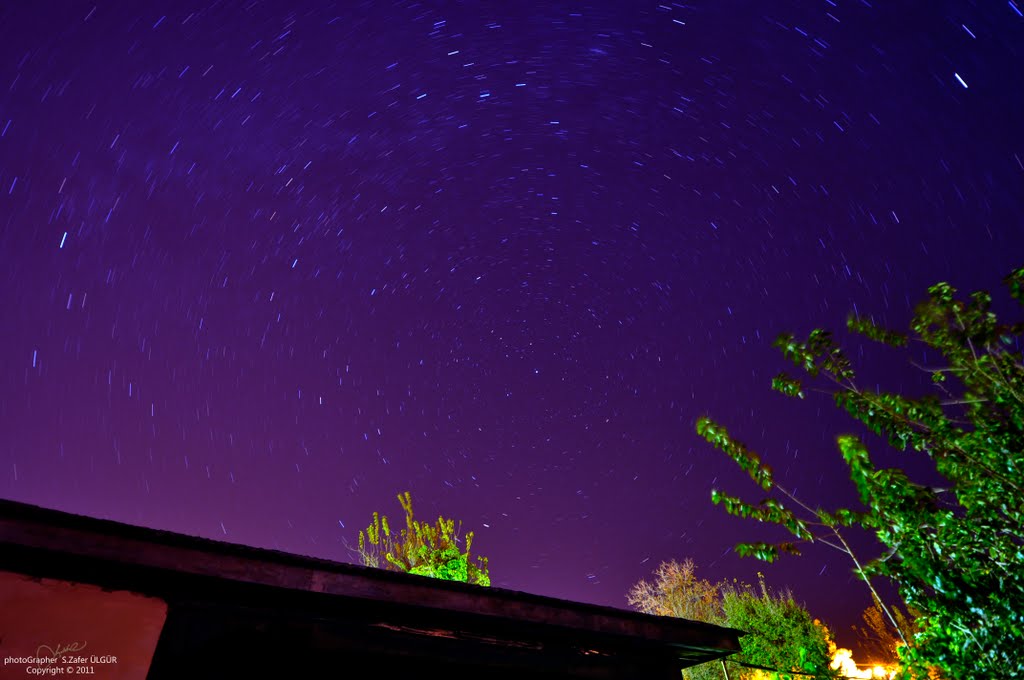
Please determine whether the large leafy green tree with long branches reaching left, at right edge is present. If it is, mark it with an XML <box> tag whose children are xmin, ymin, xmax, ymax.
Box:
<box><xmin>696</xmin><ymin>268</ymin><xmax>1024</xmax><ymax>678</ymax></box>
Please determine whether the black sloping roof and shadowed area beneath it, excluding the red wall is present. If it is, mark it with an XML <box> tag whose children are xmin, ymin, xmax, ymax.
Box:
<box><xmin>0</xmin><ymin>501</ymin><xmax>741</xmax><ymax>680</ymax></box>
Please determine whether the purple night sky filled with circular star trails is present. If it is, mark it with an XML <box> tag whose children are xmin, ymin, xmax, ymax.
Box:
<box><xmin>0</xmin><ymin>0</ymin><xmax>1024</xmax><ymax>644</ymax></box>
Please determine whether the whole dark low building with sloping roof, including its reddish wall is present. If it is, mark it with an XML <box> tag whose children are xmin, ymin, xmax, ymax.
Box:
<box><xmin>0</xmin><ymin>501</ymin><xmax>741</xmax><ymax>680</ymax></box>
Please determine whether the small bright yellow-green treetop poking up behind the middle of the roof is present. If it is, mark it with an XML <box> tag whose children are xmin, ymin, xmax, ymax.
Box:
<box><xmin>358</xmin><ymin>492</ymin><xmax>490</xmax><ymax>586</ymax></box>
